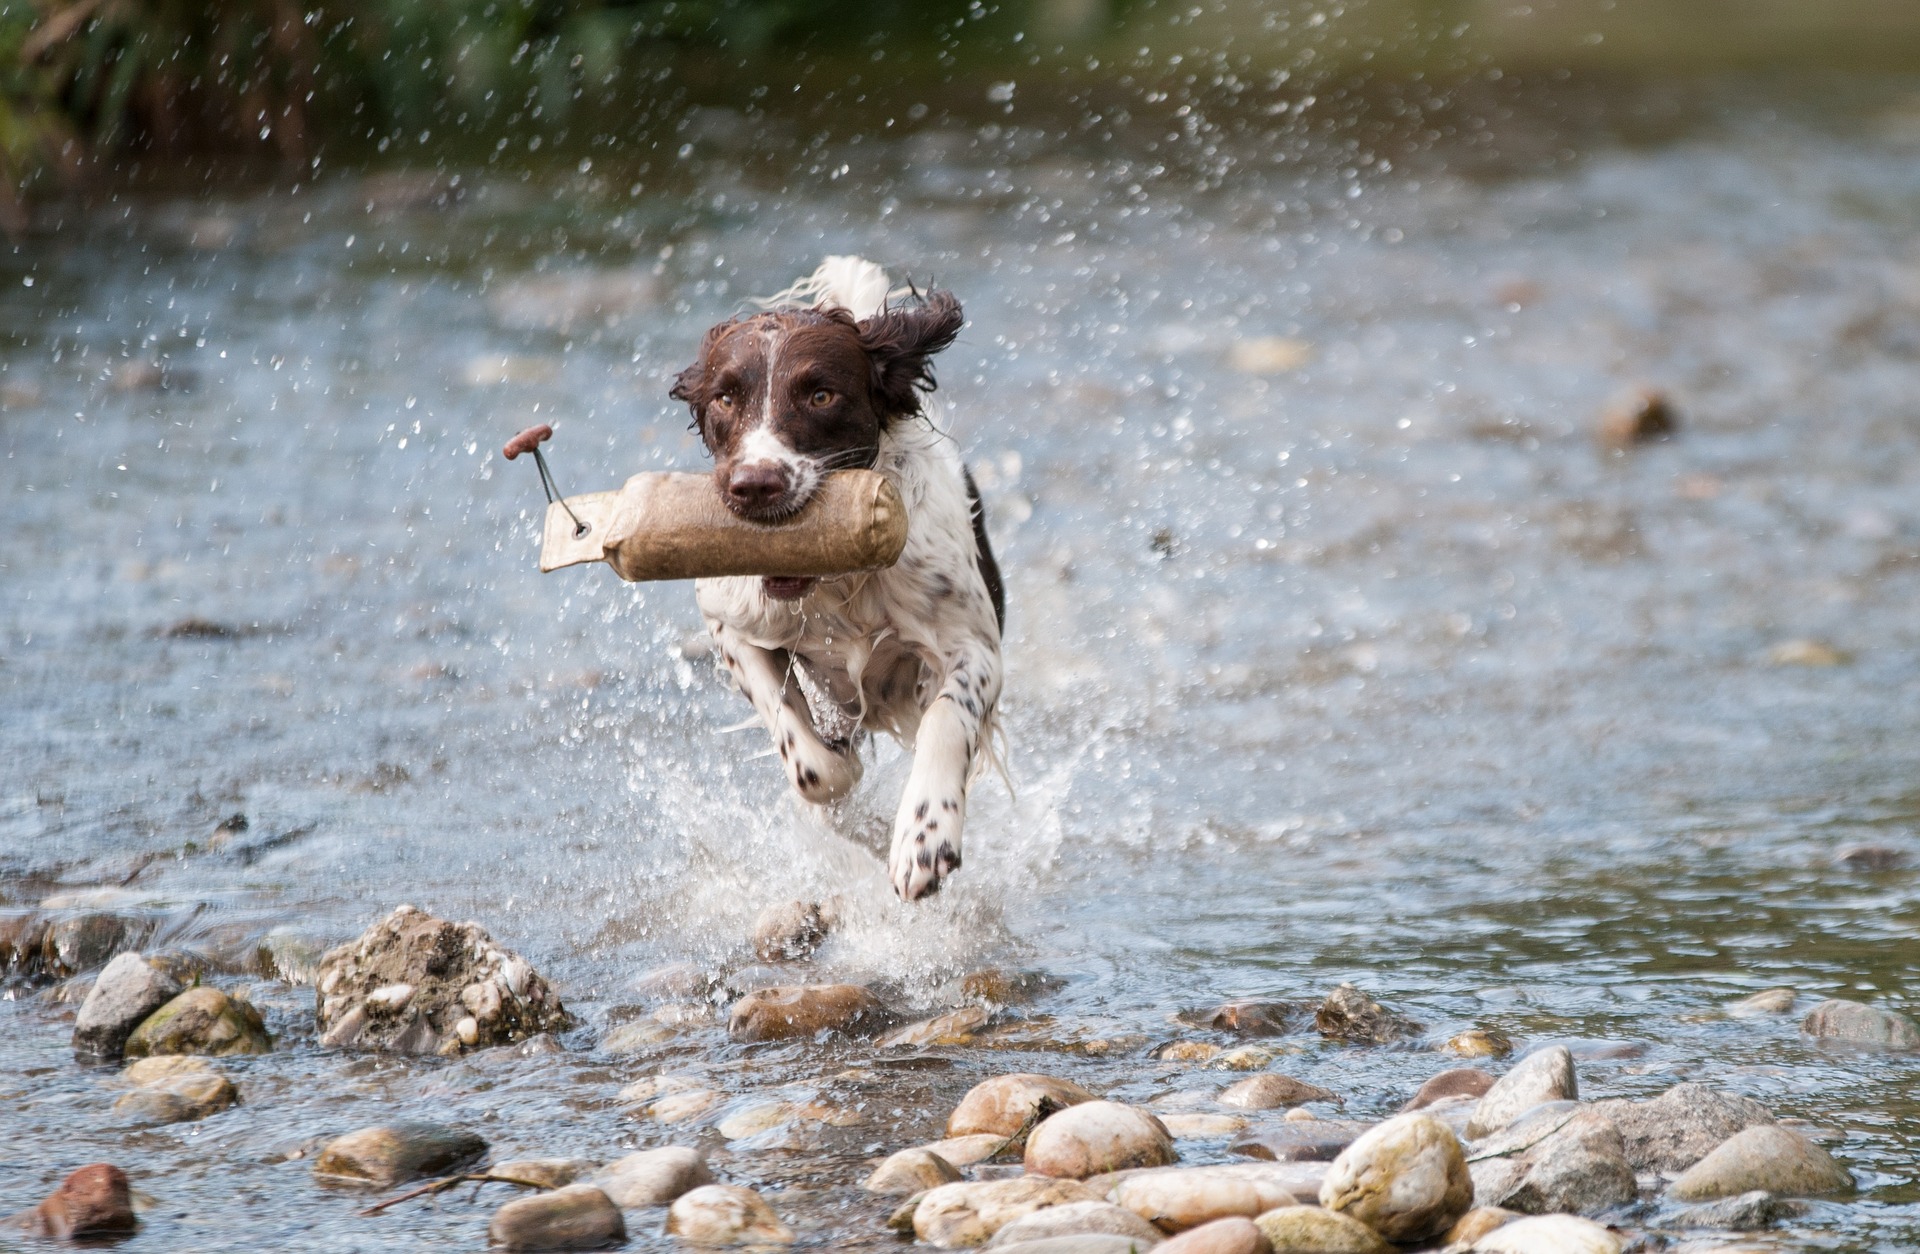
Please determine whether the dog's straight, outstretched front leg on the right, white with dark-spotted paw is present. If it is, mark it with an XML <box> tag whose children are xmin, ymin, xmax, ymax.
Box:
<box><xmin>887</xmin><ymin>645</ymin><xmax>1000</xmax><ymax>901</ymax></box>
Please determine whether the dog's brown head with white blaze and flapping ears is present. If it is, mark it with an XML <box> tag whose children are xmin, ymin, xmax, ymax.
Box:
<box><xmin>672</xmin><ymin>292</ymin><xmax>962</xmax><ymax>522</ymax></box>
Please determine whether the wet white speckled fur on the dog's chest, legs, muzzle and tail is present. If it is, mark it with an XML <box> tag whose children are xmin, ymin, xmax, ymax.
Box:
<box><xmin>695</xmin><ymin>257</ymin><xmax>1002</xmax><ymax>901</ymax></box>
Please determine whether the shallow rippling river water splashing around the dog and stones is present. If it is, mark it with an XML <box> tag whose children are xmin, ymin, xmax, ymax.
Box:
<box><xmin>0</xmin><ymin>79</ymin><xmax>1920</xmax><ymax>1250</ymax></box>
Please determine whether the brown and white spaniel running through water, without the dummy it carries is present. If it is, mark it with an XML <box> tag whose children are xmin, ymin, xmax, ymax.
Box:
<box><xmin>670</xmin><ymin>257</ymin><xmax>1006</xmax><ymax>901</ymax></box>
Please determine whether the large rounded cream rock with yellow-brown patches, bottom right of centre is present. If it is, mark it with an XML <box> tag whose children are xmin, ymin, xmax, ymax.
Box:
<box><xmin>1320</xmin><ymin>1114</ymin><xmax>1473</xmax><ymax>1242</ymax></box>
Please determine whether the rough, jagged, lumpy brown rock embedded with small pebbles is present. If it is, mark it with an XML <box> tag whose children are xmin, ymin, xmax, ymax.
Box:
<box><xmin>315</xmin><ymin>906</ymin><xmax>572</xmax><ymax>1054</ymax></box>
